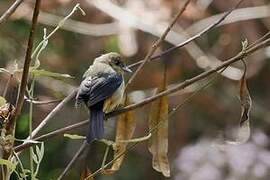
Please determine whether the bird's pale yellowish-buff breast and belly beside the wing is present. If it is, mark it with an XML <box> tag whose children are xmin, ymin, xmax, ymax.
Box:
<box><xmin>103</xmin><ymin>81</ymin><xmax>125</xmax><ymax>113</ymax></box>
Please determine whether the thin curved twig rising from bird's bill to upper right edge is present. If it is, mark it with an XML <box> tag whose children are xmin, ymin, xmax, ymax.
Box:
<box><xmin>128</xmin><ymin>0</ymin><xmax>244</xmax><ymax>68</ymax></box>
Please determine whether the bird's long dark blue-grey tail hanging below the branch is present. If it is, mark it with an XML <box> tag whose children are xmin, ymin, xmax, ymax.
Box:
<box><xmin>86</xmin><ymin>103</ymin><xmax>104</xmax><ymax>143</ymax></box>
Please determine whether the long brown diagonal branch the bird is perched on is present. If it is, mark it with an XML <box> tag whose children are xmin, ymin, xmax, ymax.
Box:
<box><xmin>15</xmin><ymin>33</ymin><xmax>270</xmax><ymax>152</ymax></box>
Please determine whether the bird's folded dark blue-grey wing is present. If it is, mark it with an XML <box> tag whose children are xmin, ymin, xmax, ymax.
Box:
<box><xmin>76</xmin><ymin>73</ymin><xmax>123</xmax><ymax>107</ymax></box>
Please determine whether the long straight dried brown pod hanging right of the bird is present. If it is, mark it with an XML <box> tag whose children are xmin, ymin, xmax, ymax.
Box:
<box><xmin>148</xmin><ymin>84</ymin><xmax>170</xmax><ymax>177</ymax></box>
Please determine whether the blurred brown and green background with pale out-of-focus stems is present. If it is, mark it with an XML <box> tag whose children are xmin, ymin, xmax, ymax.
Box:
<box><xmin>0</xmin><ymin>0</ymin><xmax>270</xmax><ymax>180</ymax></box>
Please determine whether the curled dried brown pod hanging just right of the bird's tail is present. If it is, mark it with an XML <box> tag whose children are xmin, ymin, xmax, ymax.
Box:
<box><xmin>103</xmin><ymin>97</ymin><xmax>136</xmax><ymax>175</ymax></box>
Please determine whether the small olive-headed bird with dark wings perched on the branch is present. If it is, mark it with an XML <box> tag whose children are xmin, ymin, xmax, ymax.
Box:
<box><xmin>75</xmin><ymin>52</ymin><xmax>132</xmax><ymax>144</ymax></box>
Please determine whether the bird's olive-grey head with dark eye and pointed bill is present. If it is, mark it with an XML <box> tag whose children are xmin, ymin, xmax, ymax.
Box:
<box><xmin>95</xmin><ymin>52</ymin><xmax>132</xmax><ymax>74</ymax></box>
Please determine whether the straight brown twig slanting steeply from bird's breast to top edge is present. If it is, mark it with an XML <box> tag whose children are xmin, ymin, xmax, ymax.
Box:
<box><xmin>126</xmin><ymin>0</ymin><xmax>190</xmax><ymax>88</ymax></box>
